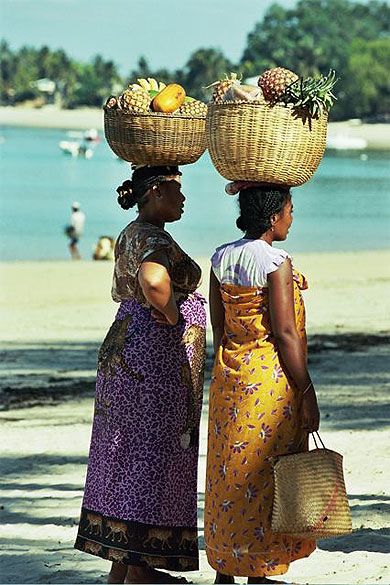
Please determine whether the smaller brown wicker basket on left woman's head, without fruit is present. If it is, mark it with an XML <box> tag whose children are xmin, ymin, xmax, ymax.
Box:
<box><xmin>104</xmin><ymin>109</ymin><xmax>206</xmax><ymax>165</ymax></box>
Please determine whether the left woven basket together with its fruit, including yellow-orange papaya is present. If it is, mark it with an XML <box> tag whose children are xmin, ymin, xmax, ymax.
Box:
<box><xmin>104</xmin><ymin>78</ymin><xmax>207</xmax><ymax>165</ymax></box>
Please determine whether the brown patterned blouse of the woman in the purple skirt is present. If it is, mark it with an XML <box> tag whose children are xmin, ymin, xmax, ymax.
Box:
<box><xmin>111</xmin><ymin>221</ymin><xmax>202</xmax><ymax>307</ymax></box>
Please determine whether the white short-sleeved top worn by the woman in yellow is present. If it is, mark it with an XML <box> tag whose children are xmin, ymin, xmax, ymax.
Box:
<box><xmin>211</xmin><ymin>238</ymin><xmax>291</xmax><ymax>287</ymax></box>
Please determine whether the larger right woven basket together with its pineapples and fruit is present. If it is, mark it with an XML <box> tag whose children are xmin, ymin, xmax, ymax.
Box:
<box><xmin>206</xmin><ymin>67</ymin><xmax>336</xmax><ymax>186</ymax></box>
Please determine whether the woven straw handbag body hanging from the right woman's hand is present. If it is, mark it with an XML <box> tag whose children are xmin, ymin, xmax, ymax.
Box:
<box><xmin>272</xmin><ymin>449</ymin><xmax>352</xmax><ymax>539</ymax></box>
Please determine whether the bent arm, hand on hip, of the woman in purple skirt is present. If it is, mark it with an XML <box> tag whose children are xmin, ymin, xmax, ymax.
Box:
<box><xmin>138</xmin><ymin>252</ymin><xmax>179</xmax><ymax>325</ymax></box>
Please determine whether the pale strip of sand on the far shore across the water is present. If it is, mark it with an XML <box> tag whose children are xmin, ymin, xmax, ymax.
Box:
<box><xmin>0</xmin><ymin>106</ymin><xmax>390</xmax><ymax>150</ymax></box>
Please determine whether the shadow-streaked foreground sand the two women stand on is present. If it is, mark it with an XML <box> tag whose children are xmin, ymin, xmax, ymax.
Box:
<box><xmin>0</xmin><ymin>250</ymin><xmax>390</xmax><ymax>585</ymax></box>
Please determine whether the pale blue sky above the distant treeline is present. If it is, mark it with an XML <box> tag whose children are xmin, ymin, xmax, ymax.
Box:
<box><xmin>0</xmin><ymin>0</ymin><xmax>296</xmax><ymax>75</ymax></box>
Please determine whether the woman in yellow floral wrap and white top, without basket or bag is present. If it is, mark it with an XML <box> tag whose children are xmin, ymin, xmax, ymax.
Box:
<box><xmin>205</xmin><ymin>182</ymin><xmax>319</xmax><ymax>583</ymax></box>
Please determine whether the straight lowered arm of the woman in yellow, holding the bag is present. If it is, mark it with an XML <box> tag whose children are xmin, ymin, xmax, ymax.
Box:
<box><xmin>268</xmin><ymin>259</ymin><xmax>319</xmax><ymax>431</ymax></box>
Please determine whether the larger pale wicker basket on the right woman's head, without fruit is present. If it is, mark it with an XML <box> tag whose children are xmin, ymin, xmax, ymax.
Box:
<box><xmin>206</xmin><ymin>102</ymin><xmax>328</xmax><ymax>187</ymax></box>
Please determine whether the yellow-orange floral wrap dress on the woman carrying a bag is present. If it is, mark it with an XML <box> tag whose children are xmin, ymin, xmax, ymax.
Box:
<box><xmin>205</xmin><ymin>271</ymin><xmax>316</xmax><ymax>577</ymax></box>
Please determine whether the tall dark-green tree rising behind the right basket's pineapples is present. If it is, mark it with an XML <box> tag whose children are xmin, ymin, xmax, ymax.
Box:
<box><xmin>241</xmin><ymin>0</ymin><xmax>390</xmax><ymax>119</ymax></box>
